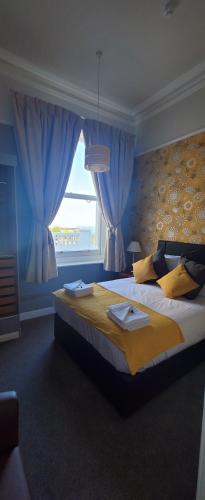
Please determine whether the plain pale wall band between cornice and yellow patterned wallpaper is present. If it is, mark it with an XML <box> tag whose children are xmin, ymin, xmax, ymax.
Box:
<box><xmin>136</xmin><ymin>88</ymin><xmax>205</xmax><ymax>155</ymax></box>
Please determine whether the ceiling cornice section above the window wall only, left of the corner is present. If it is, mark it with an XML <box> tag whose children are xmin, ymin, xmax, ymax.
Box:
<box><xmin>0</xmin><ymin>48</ymin><xmax>134</xmax><ymax>130</ymax></box>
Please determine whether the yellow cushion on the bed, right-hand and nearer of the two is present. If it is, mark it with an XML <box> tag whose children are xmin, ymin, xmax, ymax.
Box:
<box><xmin>157</xmin><ymin>264</ymin><xmax>199</xmax><ymax>299</ymax></box>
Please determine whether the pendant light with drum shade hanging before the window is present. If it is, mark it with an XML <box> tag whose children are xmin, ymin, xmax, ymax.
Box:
<box><xmin>85</xmin><ymin>50</ymin><xmax>110</xmax><ymax>173</ymax></box>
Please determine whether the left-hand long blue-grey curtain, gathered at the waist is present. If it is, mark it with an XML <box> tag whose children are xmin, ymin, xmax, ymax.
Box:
<box><xmin>11</xmin><ymin>91</ymin><xmax>82</xmax><ymax>283</ymax></box>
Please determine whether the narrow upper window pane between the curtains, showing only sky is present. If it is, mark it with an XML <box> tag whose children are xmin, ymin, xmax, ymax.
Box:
<box><xmin>66</xmin><ymin>136</ymin><xmax>96</xmax><ymax>196</ymax></box>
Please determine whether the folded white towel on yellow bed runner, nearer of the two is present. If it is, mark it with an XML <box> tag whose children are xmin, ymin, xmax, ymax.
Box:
<box><xmin>107</xmin><ymin>302</ymin><xmax>150</xmax><ymax>331</ymax></box>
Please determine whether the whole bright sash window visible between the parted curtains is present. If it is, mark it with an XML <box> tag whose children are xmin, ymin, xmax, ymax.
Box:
<box><xmin>50</xmin><ymin>134</ymin><xmax>105</xmax><ymax>265</ymax></box>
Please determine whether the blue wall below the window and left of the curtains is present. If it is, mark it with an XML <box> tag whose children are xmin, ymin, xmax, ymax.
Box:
<box><xmin>0</xmin><ymin>124</ymin><xmax>116</xmax><ymax>312</ymax></box>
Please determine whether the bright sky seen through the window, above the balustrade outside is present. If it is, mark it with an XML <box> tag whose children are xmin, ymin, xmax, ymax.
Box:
<box><xmin>50</xmin><ymin>140</ymin><xmax>96</xmax><ymax>228</ymax></box>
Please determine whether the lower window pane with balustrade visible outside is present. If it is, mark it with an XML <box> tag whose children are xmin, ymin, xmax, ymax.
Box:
<box><xmin>50</xmin><ymin>198</ymin><xmax>99</xmax><ymax>252</ymax></box>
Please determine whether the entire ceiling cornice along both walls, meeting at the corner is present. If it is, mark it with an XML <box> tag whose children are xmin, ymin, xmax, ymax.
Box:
<box><xmin>0</xmin><ymin>48</ymin><xmax>205</xmax><ymax>132</ymax></box>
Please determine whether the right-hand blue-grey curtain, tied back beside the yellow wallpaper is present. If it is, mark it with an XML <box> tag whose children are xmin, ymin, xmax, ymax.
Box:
<box><xmin>83</xmin><ymin>120</ymin><xmax>134</xmax><ymax>272</ymax></box>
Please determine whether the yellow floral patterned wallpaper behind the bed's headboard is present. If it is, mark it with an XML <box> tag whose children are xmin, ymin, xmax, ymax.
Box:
<box><xmin>136</xmin><ymin>132</ymin><xmax>205</xmax><ymax>253</ymax></box>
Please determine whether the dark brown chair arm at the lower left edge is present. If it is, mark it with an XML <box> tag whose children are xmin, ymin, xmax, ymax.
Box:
<box><xmin>0</xmin><ymin>391</ymin><xmax>18</xmax><ymax>451</ymax></box>
